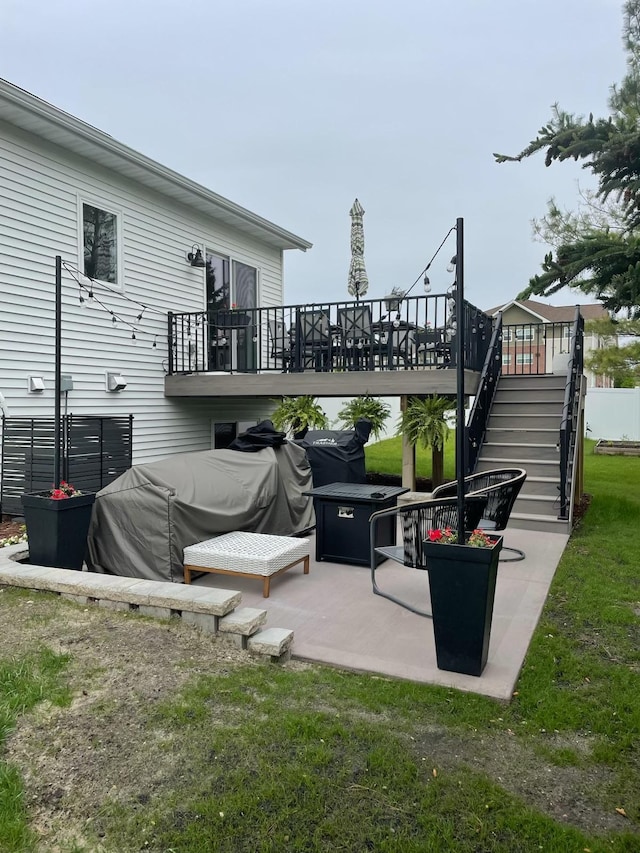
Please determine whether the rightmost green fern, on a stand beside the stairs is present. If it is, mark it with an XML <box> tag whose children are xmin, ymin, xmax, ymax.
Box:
<box><xmin>396</xmin><ymin>394</ymin><xmax>455</xmax><ymax>487</ymax></box>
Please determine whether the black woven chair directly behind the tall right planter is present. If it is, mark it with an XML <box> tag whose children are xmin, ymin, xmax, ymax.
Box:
<box><xmin>369</xmin><ymin>495</ymin><xmax>487</xmax><ymax>618</ymax></box>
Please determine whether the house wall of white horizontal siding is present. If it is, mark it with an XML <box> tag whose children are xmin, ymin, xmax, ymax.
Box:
<box><xmin>0</xmin><ymin>122</ymin><xmax>283</xmax><ymax>462</ymax></box>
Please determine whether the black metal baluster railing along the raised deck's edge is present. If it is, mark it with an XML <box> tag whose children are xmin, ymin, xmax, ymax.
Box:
<box><xmin>168</xmin><ymin>294</ymin><xmax>492</xmax><ymax>374</ymax></box>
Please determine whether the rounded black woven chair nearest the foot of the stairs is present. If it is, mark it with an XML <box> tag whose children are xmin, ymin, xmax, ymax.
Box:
<box><xmin>431</xmin><ymin>468</ymin><xmax>527</xmax><ymax>563</ymax></box>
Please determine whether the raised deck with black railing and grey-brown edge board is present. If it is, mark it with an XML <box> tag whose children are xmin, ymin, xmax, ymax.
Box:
<box><xmin>165</xmin><ymin>294</ymin><xmax>492</xmax><ymax>396</ymax></box>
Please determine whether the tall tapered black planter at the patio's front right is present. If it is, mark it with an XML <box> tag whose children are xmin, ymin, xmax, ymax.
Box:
<box><xmin>423</xmin><ymin>536</ymin><xmax>502</xmax><ymax>675</ymax></box>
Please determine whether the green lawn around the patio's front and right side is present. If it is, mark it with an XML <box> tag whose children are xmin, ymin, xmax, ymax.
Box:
<box><xmin>0</xmin><ymin>440</ymin><xmax>640</xmax><ymax>853</ymax></box>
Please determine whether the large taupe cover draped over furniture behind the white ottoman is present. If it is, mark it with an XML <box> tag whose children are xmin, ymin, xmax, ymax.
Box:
<box><xmin>87</xmin><ymin>442</ymin><xmax>315</xmax><ymax>582</ymax></box>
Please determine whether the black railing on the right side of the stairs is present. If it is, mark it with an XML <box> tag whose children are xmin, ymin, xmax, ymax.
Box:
<box><xmin>558</xmin><ymin>306</ymin><xmax>584</xmax><ymax>520</ymax></box>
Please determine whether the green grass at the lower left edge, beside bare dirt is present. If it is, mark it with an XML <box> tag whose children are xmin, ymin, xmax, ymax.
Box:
<box><xmin>0</xmin><ymin>649</ymin><xmax>69</xmax><ymax>853</ymax></box>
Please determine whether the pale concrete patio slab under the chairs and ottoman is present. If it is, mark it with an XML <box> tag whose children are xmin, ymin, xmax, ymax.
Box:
<box><xmin>194</xmin><ymin>529</ymin><xmax>568</xmax><ymax>701</ymax></box>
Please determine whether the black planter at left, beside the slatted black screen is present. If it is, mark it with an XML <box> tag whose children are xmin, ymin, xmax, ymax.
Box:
<box><xmin>22</xmin><ymin>492</ymin><xmax>96</xmax><ymax>569</ymax></box>
